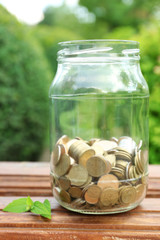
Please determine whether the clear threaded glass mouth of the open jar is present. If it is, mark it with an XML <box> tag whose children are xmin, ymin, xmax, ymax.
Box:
<box><xmin>58</xmin><ymin>39</ymin><xmax>140</xmax><ymax>61</ymax></box>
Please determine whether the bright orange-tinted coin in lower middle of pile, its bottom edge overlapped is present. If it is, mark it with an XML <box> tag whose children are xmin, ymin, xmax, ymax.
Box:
<box><xmin>97</xmin><ymin>174</ymin><xmax>119</xmax><ymax>190</ymax></box>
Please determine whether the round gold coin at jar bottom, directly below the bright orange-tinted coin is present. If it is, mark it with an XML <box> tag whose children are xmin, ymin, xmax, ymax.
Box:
<box><xmin>100</xmin><ymin>188</ymin><xmax>118</xmax><ymax>207</ymax></box>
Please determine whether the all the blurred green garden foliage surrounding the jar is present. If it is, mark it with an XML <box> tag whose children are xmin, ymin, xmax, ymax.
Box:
<box><xmin>0</xmin><ymin>0</ymin><xmax>160</xmax><ymax>163</ymax></box>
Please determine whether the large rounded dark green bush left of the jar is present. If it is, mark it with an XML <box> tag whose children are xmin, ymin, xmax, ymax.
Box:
<box><xmin>0</xmin><ymin>6</ymin><xmax>52</xmax><ymax>161</ymax></box>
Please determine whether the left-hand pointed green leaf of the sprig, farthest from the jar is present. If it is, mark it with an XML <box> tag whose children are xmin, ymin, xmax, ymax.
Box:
<box><xmin>3</xmin><ymin>198</ymin><xmax>28</xmax><ymax>213</ymax></box>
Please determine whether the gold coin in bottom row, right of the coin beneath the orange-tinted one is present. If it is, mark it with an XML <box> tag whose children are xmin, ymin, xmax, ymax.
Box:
<box><xmin>120</xmin><ymin>186</ymin><xmax>136</xmax><ymax>204</ymax></box>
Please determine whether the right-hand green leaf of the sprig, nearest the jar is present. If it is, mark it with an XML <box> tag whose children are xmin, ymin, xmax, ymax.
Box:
<box><xmin>31</xmin><ymin>201</ymin><xmax>51</xmax><ymax>219</ymax></box>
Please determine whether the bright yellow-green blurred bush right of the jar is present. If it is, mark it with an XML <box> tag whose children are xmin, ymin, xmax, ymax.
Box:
<box><xmin>104</xmin><ymin>22</ymin><xmax>160</xmax><ymax>164</ymax></box>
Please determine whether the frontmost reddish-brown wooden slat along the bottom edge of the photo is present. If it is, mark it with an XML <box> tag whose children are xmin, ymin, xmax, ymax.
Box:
<box><xmin>0</xmin><ymin>228</ymin><xmax>160</xmax><ymax>240</ymax></box>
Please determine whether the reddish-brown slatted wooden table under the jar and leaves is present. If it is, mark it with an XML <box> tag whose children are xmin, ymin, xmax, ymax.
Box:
<box><xmin>0</xmin><ymin>162</ymin><xmax>160</xmax><ymax>240</ymax></box>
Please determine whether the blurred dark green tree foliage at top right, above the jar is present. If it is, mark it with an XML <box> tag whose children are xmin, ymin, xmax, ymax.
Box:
<box><xmin>80</xmin><ymin>0</ymin><xmax>160</xmax><ymax>29</ymax></box>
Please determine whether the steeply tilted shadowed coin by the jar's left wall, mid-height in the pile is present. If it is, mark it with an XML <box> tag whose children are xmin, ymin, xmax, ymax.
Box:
<box><xmin>54</xmin><ymin>153</ymin><xmax>70</xmax><ymax>177</ymax></box>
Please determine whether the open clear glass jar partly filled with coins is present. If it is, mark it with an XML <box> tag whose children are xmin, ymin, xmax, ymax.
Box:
<box><xmin>49</xmin><ymin>40</ymin><xmax>149</xmax><ymax>214</ymax></box>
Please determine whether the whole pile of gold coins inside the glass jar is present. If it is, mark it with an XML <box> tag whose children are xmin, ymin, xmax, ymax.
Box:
<box><xmin>50</xmin><ymin>135</ymin><xmax>148</xmax><ymax>211</ymax></box>
